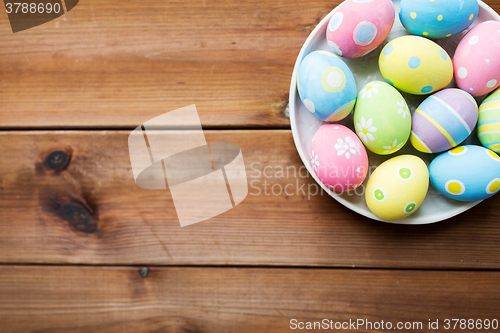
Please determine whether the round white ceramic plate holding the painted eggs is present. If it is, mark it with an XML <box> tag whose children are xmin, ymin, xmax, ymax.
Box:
<box><xmin>290</xmin><ymin>0</ymin><xmax>500</xmax><ymax>224</ymax></box>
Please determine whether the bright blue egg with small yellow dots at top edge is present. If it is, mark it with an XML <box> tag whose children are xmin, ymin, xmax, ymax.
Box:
<box><xmin>398</xmin><ymin>0</ymin><xmax>479</xmax><ymax>38</ymax></box>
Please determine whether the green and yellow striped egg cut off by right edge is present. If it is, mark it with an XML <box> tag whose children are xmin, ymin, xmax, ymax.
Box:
<box><xmin>477</xmin><ymin>88</ymin><xmax>500</xmax><ymax>153</ymax></box>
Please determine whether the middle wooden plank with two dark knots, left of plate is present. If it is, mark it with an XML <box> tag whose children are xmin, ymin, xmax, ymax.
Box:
<box><xmin>0</xmin><ymin>130</ymin><xmax>500</xmax><ymax>269</ymax></box>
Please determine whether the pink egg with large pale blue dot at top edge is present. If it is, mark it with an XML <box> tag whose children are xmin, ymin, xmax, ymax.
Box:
<box><xmin>326</xmin><ymin>0</ymin><xmax>395</xmax><ymax>58</ymax></box>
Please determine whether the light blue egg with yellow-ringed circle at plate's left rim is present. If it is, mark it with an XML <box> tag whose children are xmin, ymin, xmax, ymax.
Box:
<box><xmin>297</xmin><ymin>51</ymin><xmax>357</xmax><ymax>121</ymax></box>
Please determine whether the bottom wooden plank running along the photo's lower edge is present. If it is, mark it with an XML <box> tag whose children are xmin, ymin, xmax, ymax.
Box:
<box><xmin>0</xmin><ymin>266</ymin><xmax>500</xmax><ymax>333</ymax></box>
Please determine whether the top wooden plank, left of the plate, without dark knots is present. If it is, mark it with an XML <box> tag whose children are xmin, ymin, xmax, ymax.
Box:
<box><xmin>0</xmin><ymin>0</ymin><xmax>339</xmax><ymax>128</ymax></box>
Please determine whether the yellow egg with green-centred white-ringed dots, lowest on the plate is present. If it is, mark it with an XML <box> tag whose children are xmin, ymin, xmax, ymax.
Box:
<box><xmin>365</xmin><ymin>155</ymin><xmax>429</xmax><ymax>220</ymax></box>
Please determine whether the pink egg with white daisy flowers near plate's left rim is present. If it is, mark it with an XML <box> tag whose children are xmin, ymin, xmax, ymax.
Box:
<box><xmin>311</xmin><ymin>124</ymin><xmax>368</xmax><ymax>192</ymax></box>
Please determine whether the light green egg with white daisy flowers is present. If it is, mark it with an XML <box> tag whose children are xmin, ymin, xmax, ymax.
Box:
<box><xmin>354</xmin><ymin>81</ymin><xmax>411</xmax><ymax>155</ymax></box>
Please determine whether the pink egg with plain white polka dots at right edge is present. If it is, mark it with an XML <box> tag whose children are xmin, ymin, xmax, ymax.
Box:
<box><xmin>453</xmin><ymin>21</ymin><xmax>500</xmax><ymax>97</ymax></box>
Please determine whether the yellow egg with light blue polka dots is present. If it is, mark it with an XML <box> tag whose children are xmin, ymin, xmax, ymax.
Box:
<box><xmin>379</xmin><ymin>36</ymin><xmax>453</xmax><ymax>95</ymax></box>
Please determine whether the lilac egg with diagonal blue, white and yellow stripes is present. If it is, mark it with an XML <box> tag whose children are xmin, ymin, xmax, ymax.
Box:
<box><xmin>410</xmin><ymin>88</ymin><xmax>478</xmax><ymax>153</ymax></box>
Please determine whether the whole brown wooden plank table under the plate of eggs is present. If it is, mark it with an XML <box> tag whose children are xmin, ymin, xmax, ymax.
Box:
<box><xmin>0</xmin><ymin>0</ymin><xmax>500</xmax><ymax>333</ymax></box>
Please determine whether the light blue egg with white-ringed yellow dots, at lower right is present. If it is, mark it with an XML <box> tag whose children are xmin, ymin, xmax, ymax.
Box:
<box><xmin>429</xmin><ymin>146</ymin><xmax>500</xmax><ymax>201</ymax></box>
